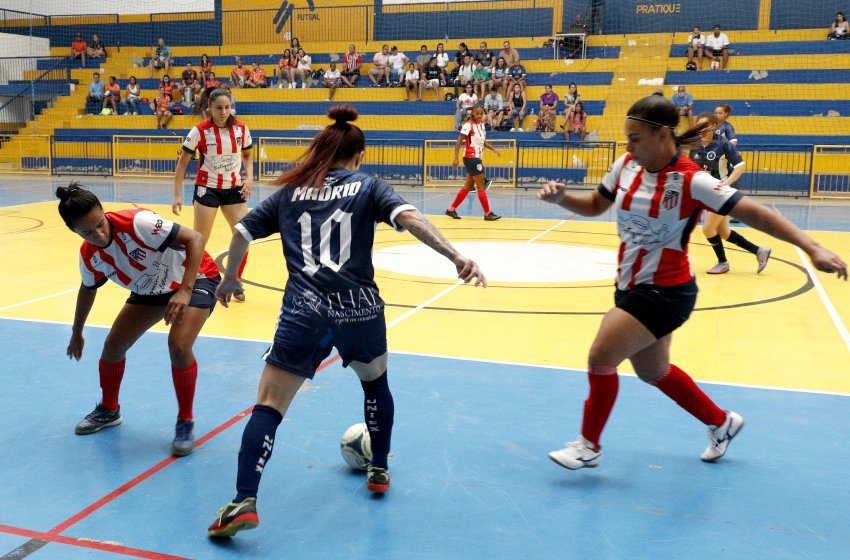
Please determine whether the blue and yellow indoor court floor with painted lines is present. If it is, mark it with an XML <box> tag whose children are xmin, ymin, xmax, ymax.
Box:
<box><xmin>0</xmin><ymin>176</ymin><xmax>850</xmax><ymax>560</ymax></box>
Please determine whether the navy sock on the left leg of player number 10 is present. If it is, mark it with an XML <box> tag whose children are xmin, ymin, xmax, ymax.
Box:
<box><xmin>233</xmin><ymin>404</ymin><xmax>283</xmax><ymax>502</ymax></box>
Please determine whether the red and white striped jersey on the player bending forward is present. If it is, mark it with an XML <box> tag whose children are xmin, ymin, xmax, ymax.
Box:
<box><xmin>80</xmin><ymin>208</ymin><xmax>218</xmax><ymax>295</ymax></box>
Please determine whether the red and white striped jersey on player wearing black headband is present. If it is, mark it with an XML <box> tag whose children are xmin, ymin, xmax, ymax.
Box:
<box><xmin>599</xmin><ymin>153</ymin><xmax>742</xmax><ymax>290</ymax></box>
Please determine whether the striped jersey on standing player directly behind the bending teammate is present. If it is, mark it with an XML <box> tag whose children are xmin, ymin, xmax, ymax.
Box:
<box><xmin>183</xmin><ymin>119</ymin><xmax>253</xmax><ymax>189</ymax></box>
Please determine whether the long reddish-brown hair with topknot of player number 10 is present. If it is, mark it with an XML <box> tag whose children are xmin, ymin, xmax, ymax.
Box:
<box><xmin>272</xmin><ymin>105</ymin><xmax>366</xmax><ymax>187</ymax></box>
